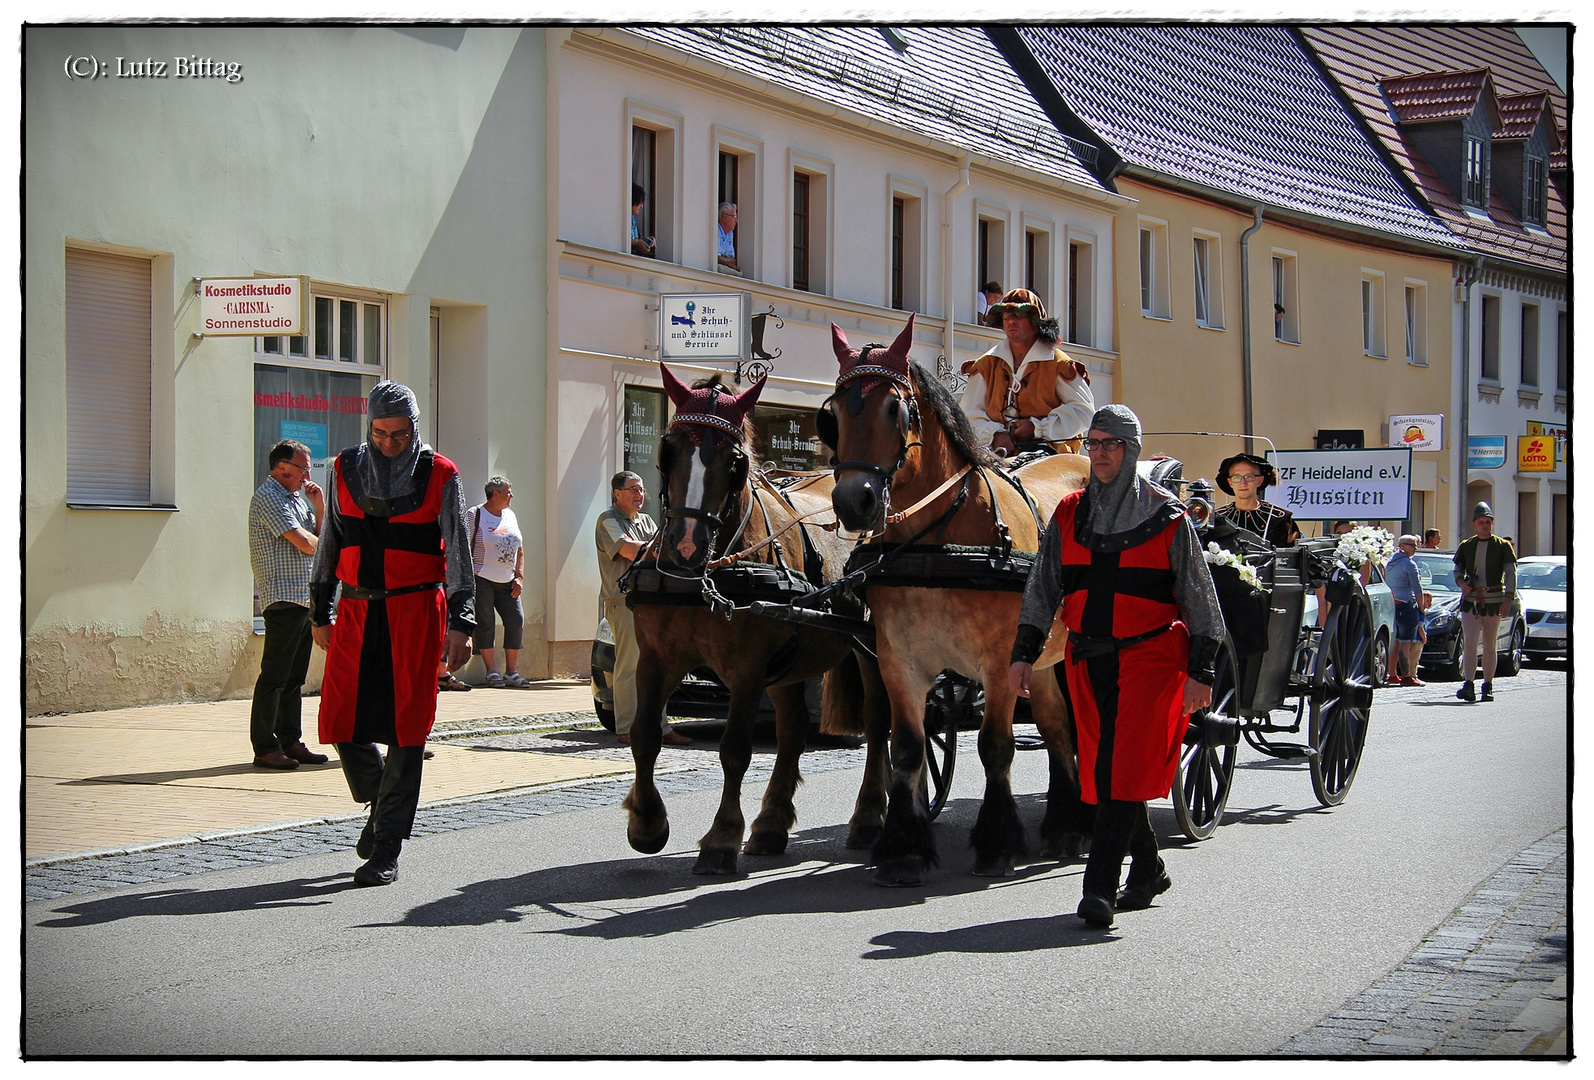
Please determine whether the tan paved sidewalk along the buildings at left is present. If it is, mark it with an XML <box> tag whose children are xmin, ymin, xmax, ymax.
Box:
<box><xmin>22</xmin><ymin>680</ymin><xmax>630</xmax><ymax>859</ymax></box>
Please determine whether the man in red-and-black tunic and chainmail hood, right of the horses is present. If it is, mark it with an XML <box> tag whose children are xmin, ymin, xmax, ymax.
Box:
<box><xmin>1009</xmin><ymin>405</ymin><xmax>1224</xmax><ymax>925</ymax></box>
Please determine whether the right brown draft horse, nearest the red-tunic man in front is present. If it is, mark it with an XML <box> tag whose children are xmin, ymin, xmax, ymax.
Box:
<box><xmin>816</xmin><ymin>315</ymin><xmax>1090</xmax><ymax>886</ymax></box>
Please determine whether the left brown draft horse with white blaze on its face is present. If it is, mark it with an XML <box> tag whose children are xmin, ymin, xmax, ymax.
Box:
<box><xmin>623</xmin><ymin>365</ymin><xmax>889</xmax><ymax>873</ymax></box>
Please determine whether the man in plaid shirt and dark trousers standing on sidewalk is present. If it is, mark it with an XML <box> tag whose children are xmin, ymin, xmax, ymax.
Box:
<box><xmin>249</xmin><ymin>440</ymin><xmax>327</xmax><ymax>769</ymax></box>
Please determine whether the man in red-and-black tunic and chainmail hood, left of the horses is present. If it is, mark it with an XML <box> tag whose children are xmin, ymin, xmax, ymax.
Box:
<box><xmin>311</xmin><ymin>382</ymin><xmax>475</xmax><ymax>886</ymax></box>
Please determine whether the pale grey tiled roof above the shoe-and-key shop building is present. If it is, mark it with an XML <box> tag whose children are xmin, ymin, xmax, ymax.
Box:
<box><xmin>625</xmin><ymin>25</ymin><xmax>1103</xmax><ymax>191</ymax></box>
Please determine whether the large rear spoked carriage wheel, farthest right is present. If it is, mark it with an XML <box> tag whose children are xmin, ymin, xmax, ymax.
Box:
<box><xmin>1309</xmin><ymin>581</ymin><xmax>1377</xmax><ymax>806</ymax></box>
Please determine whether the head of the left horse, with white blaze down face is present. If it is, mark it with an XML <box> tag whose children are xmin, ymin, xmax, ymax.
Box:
<box><xmin>658</xmin><ymin>365</ymin><xmax>764</xmax><ymax>570</ymax></box>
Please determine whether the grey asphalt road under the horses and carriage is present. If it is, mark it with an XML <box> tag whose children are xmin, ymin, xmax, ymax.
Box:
<box><xmin>22</xmin><ymin>669</ymin><xmax>1568</xmax><ymax>1056</ymax></box>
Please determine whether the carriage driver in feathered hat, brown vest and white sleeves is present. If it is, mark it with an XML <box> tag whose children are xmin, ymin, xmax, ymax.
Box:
<box><xmin>963</xmin><ymin>288</ymin><xmax>1095</xmax><ymax>457</ymax></box>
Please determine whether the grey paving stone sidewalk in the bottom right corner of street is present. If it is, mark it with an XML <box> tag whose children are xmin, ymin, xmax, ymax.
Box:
<box><xmin>1274</xmin><ymin>828</ymin><xmax>1570</xmax><ymax>1059</ymax></box>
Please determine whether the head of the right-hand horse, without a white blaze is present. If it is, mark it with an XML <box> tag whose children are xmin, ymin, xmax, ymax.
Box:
<box><xmin>815</xmin><ymin>315</ymin><xmax>920</xmax><ymax>532</ymax></box>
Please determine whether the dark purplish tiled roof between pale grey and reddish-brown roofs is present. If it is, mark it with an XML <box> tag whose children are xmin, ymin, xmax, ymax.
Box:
<box><xmin>1019</xmin><ymin>24</ymin><xmax>1455</xmax><ymax>247</ymax></box>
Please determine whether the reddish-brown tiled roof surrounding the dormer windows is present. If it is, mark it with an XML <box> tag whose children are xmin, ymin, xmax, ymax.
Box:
<box><xmin>1298</xmin><ymin>25</ymin><xmax>1567</xmax><ymax>272</ymax></box>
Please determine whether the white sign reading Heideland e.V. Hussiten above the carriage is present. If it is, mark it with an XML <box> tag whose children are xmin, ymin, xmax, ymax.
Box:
<box><xmin>1267</xmin><ymin>448</ymin><xmax>1411</xmax><ymax>521</ymax></box>
